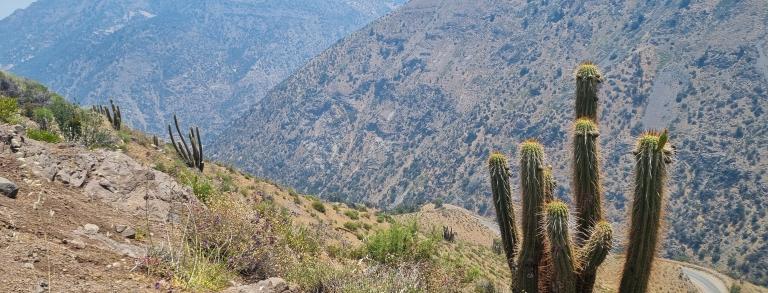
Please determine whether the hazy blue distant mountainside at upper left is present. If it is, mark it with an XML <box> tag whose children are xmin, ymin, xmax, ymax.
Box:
<box><xmin>0</xmin><ymin>0</ymin><xmax>402</xmax><ymax>131</ymax></box>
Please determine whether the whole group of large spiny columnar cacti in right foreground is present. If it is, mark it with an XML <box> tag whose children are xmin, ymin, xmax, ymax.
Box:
<box><xmin>488</xmin><ymin>62</ymin><xmax>672</xmax><ymax>293</ymax></box>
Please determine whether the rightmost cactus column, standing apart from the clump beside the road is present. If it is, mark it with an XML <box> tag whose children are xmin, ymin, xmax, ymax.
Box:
<box><xmin>619</xmin><ymin>131</ymin><xmax>672</xmax><ymax>293</ymax></box>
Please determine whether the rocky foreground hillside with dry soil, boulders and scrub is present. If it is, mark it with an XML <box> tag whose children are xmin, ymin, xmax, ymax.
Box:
<box><xmin>0</xmin><ymin>74</ymin><xmax>766</xmax><ymax>293</ymax></box>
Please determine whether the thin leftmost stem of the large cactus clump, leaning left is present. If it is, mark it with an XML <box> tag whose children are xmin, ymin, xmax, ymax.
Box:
<box><xmin>488</xmin><ymin>153</ymin><xmax>518</xmax><ymax>276</ymax></box>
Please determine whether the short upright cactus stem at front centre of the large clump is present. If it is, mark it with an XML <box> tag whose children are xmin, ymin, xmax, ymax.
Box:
<box><xmin>544</xmin><ymin>201</ymin><xmax>578</xmax><ymax>293</ymax></box>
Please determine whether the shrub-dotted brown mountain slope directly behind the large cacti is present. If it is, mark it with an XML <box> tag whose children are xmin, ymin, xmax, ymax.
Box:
<box><xmin>212</xmin><ymin>0</ymin><xmax>768</xmax><ymax>284</ymax></box>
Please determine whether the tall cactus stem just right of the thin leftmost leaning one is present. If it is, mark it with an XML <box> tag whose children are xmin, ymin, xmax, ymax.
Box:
<box><xmin>516</xmin><ymin>140</ymin><xmax>545</xmax><ymax>292</ymax></box>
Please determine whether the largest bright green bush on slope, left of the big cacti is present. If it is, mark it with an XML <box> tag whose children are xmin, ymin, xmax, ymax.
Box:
<box><xmin>363</xmin><ymin>222</ymin><xmax>437</xmax><ymax>263</ymax></box>
